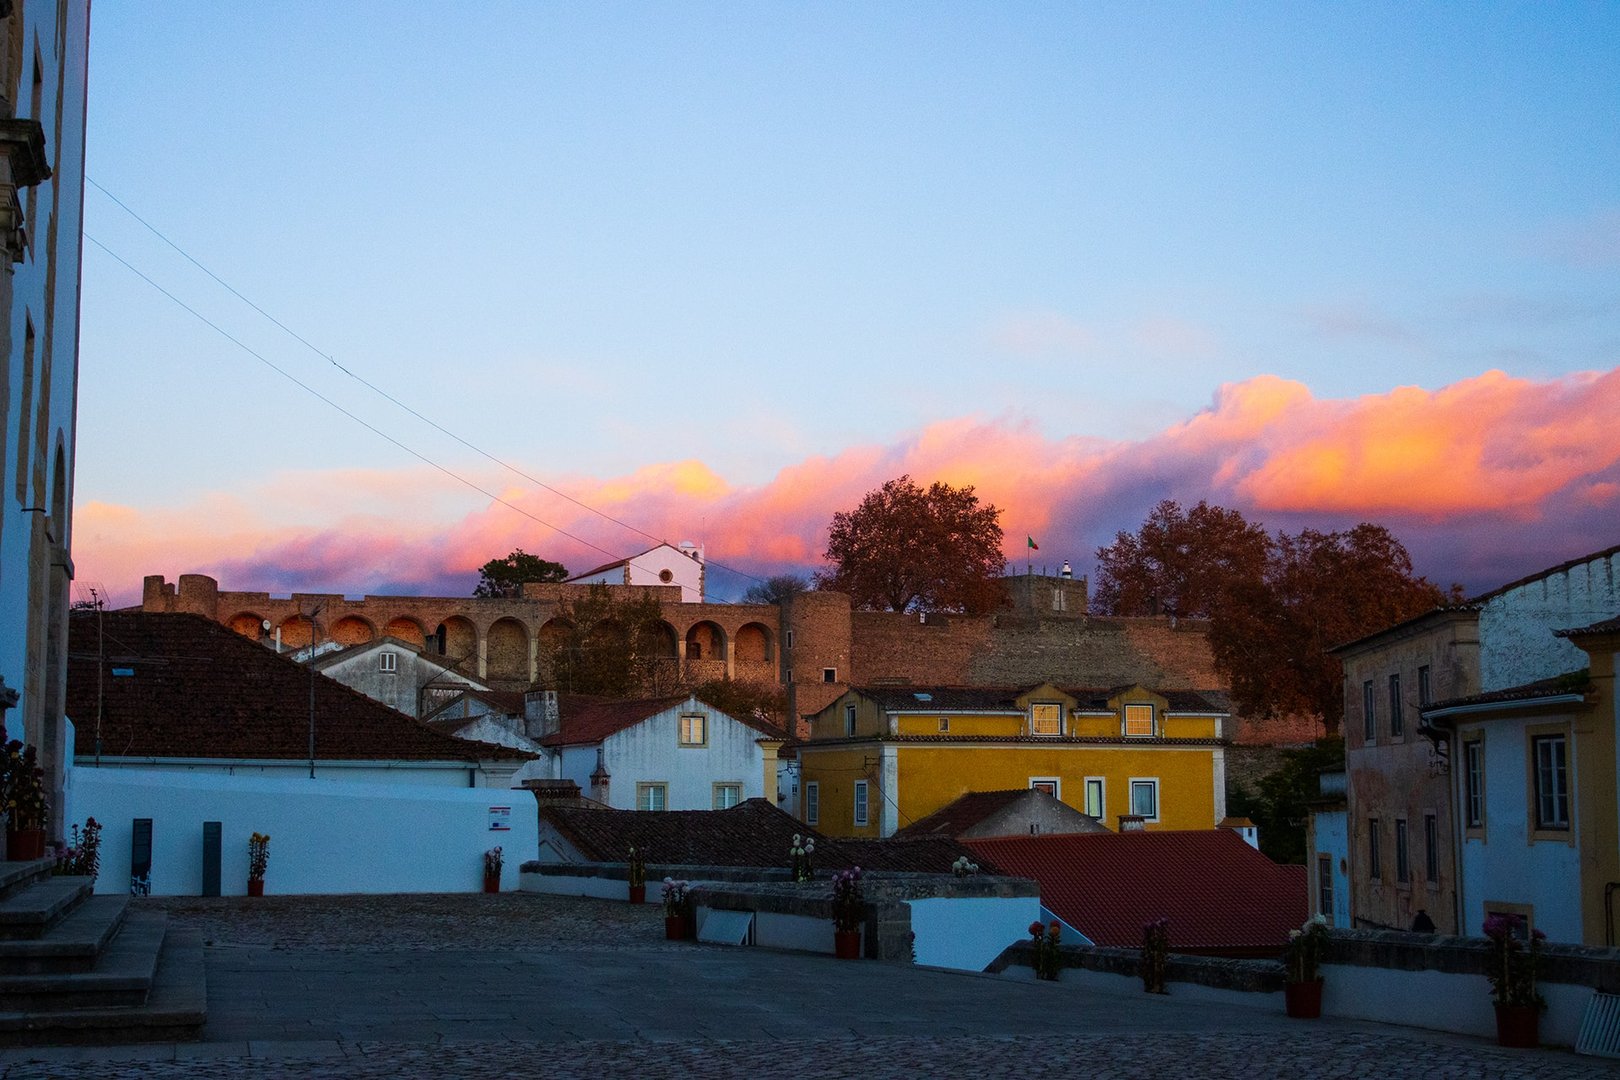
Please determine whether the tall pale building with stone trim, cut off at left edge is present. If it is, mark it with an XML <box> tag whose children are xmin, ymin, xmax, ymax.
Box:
<box><xmin>0</xmin><ymin>0</ymin><xmax>89</xmax><ymax>836</ymax></box>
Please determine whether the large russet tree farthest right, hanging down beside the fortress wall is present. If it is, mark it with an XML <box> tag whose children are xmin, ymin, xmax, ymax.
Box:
<box><xmin>1210</xmin><ymin>523</ymin><xmax>1447</xmax><ymax>735</ymax></box>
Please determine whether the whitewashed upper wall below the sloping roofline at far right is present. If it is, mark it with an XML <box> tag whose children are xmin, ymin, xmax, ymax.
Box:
<box><xmin>1479</xmin><ymin>552</ymin><xmax>1620</xmax><ymax>693</ymax></box>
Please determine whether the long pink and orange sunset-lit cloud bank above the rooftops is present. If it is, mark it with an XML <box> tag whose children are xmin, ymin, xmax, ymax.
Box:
<box><xmin>75</xmin><ymin>369</ymin><xmax>1620</xmax><ymax>601</ymax></box>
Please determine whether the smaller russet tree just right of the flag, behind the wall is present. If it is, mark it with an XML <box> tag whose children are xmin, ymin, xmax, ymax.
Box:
<box><xmin>1092</xmin><ymin>499</ymin><xmax>1270</xmax><ymax>619</ymax></box>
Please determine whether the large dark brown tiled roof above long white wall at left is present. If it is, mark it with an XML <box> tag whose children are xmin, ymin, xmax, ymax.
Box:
<box><xmin>68</xmin><ymin>610</ymin><xmax>536</xmax><ymax>763</ymax></box>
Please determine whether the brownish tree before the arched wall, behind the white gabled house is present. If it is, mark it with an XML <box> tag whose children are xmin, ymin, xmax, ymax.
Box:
<box><xmin>549</xmin><ymin>585</ymin><xmax>682</xmax><ymax>698</ymax></box>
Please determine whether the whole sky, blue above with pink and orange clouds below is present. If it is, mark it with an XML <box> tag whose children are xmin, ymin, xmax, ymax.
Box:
<box><xmin>73</xmin><ymin>0</ymin><xmax>1620</xmax><ymax>604</ymax></box>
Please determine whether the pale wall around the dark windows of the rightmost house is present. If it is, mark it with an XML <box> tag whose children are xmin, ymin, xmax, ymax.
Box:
<box><xmin>1456</xmin><ymin>714</ymin><xmax>1581</xmax><ymax>942</ymax></box>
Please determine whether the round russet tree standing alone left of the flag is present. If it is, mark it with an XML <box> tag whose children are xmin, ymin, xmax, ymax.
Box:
<box><xmin>815</xmin><ymin>476</ymin><xmax>1006</xmax><ymax>614</ymax></box>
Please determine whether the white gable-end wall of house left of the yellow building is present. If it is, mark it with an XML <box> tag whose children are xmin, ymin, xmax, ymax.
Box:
<box><xmin>559</xmin><ymin>698</ymin><xmax>765</xmax><ymax>810</ymax></box>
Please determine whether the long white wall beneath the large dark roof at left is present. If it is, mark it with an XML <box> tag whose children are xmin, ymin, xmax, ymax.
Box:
<box><xmin>66</xmin><ymin>767</ymin><xmax>539</xmax><ymax>895</ymax></box>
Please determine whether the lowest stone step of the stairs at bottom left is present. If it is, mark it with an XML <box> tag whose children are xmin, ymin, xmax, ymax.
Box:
<box><xmin>0</xmin><ymin>918</ymin><xmax>207</xmax><ymax>1046</ymax></box>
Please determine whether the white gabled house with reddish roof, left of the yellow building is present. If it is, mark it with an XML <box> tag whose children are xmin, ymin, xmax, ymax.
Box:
<box><xmin>539</xmin><ymin>695</ymin><xmax>786</xmax><ymax>810</ymax></box>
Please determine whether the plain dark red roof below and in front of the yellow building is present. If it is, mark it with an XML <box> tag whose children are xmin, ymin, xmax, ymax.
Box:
<box><xmin>962</xmin><ymin>829</ymin><xmax>1309</xmax><ymax>955</ymax></box>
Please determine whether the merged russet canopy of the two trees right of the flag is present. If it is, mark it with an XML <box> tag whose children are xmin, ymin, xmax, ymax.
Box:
<box><xmin>1095</xmin><ymin>500</ymin><xmax>1445</xmax><ymax>733</ymax></box>
